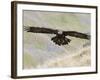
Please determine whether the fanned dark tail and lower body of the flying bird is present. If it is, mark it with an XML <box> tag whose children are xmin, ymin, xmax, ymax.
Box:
<box><xmin>51</xmin><ymin>34</ymin><xmax>71</xmax><ymax>46</ymax></box>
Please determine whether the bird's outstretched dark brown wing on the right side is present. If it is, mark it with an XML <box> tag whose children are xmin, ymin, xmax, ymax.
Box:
<box><xmin>63</xmin><ymin>31</ymin><xmax>90</xmax><ymax>39</ymax></box>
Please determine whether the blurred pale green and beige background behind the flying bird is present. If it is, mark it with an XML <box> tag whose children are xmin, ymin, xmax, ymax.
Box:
<box><xmin>23</xmin><ymin>10</ymin><xmax>91</xmax><ymax>69</ymax></box>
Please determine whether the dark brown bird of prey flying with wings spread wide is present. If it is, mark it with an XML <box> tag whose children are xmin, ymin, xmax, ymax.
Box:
<box><xmin>24</xmin><ymin>26</ymin><xmax>90</xmax><ymax>46</ymax></box>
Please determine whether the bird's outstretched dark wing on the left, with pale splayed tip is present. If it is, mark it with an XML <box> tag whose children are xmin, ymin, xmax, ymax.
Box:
<box><xmin>24</xmin><ymin>26</ymin><xmax>58</xmax><ymax>34</ymax></box>
